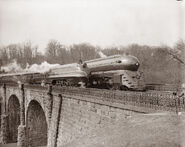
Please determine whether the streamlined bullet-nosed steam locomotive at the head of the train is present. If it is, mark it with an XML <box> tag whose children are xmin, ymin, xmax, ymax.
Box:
<box><xmin>83</xmin><ymin>55</ymin><xmax>145</xmax><ymax>90</ymax></box>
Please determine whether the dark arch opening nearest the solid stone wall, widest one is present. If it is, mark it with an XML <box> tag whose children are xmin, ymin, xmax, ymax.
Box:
<box><xmin>26</xmin><ymin>100</ymin><xmax>48</xmax><ymax>147</ymax></box>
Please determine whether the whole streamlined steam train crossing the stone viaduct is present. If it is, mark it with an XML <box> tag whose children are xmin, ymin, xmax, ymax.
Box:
<box><xmin>0</xmin><ymin>55</ymin><xmax>145</xmax><ymax>90</ymax></box>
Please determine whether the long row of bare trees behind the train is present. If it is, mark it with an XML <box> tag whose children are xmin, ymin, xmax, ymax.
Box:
<box><xmin>0</xmin><ymin>40</ymin><xmax>185</xmax><ymax>83</ymax></box>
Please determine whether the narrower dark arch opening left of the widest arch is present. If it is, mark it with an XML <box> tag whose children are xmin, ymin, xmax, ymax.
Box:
<box><xmin>7</xmin><ymin>95</ymin><xmax>20</xmax><ymax>143</ymax></box>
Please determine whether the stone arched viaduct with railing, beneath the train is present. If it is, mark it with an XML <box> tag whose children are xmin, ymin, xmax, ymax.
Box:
<box><xmin>0</xmin><ymin>84</ymin><xmax>184</xmax><ymax>147</ymax></box>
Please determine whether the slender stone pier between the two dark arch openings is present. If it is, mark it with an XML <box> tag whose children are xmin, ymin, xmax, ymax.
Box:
<box><xmin>17</xmin><ymin>84</ymin><xmax>27</xmax><ymax>147</ymax></box>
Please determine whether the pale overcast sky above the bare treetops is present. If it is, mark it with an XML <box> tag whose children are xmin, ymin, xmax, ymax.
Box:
<box><xmin>0</xmin><ymin>0</ymin><xmax>185</xmax><ymax>51</ymax></box>
